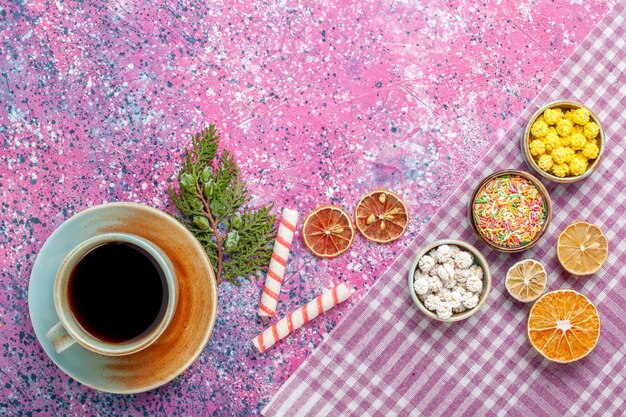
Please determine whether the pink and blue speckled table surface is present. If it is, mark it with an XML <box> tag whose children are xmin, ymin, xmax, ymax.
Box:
<box><xmin>0</xmin><ymin>0</ymin><xmax>613</xmax><ymax>416</ymax></box>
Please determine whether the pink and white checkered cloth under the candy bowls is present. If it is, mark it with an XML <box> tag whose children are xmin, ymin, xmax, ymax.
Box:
<box><xmin>263</xmin><ymin>1</ymin><xmax>626</xmax><ymax>416</ymax></box>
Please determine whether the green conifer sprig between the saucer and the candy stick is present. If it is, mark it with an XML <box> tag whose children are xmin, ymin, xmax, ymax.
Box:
<box><xmin>169</xmin><ymin>125</ymin><xmax>276</xmax><ymax>285</ymax></box>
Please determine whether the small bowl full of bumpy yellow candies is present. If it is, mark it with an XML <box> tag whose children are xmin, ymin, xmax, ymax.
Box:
<box><xmin>522</xmin><ymin>101</ymin><xmax>605</xmax><ymax>183</ymax></box>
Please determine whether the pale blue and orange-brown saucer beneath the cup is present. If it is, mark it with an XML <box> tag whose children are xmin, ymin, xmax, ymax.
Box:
<box><xmin>28</xmin><ymin>203</ymin><xmax>217</xmax><ymax>394</ymax></box>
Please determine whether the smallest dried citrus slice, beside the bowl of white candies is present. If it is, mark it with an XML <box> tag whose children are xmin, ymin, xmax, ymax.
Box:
<box><xmin>505</xmin><ymin>259</ymin><xmax>548</xmax><ymax>303</ymax></box>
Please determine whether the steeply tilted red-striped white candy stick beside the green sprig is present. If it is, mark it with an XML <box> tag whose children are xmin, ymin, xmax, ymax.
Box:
<box><xmin>259</xmin><ymin>208</ymin><xmax>298</xmax><ymax>317</ymax></box>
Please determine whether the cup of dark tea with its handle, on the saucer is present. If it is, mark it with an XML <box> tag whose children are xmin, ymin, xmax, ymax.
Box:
<box><xmin>46</xmin><ymin>233</ymin><xmax>178</xmax><ymax>356</ymax></box>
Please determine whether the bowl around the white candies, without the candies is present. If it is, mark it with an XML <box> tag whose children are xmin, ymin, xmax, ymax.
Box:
<box><xmin>409</xmin><ymin>239</ymin><xmax>491</xmax><ymax>322</ymax></box>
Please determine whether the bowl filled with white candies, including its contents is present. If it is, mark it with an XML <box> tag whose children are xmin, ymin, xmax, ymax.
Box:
<box><xmin>409</xmin><ymin>239</ymin><xmax>491</xmax><ymax>322</ymax></box>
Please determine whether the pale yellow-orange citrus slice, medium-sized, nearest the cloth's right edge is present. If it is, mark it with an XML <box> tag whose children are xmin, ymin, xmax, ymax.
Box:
<box><xmin>556</xmin><ymin>222</ymin><xmax>609</xmax><ymax>275</ymax></box>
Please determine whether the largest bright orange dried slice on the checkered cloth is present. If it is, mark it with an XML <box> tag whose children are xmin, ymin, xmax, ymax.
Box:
<box><xmin>528</xmin><ymin>290</ymin><xmax>600</xmax><ymax>363</ymax></box>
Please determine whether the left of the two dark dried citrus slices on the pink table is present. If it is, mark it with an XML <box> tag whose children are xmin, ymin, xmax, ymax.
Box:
<box><xmin>302</xmin><ymin>206</ymin><xmax>354</xmax><ymax>258</ymax></box>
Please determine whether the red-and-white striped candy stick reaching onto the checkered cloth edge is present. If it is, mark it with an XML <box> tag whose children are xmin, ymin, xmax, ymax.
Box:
<box><xmin>252</xmin><ymin>283</ymin><xmax>350</xmax><ymax>352</ymax></box>
